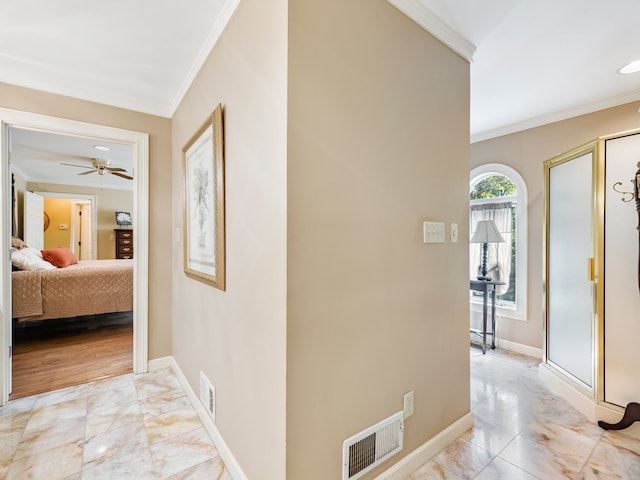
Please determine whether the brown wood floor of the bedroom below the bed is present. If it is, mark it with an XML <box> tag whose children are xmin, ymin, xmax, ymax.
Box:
<box><xmin>9</xmin><ymin>312</ymin><xmax>133</xmax><ymax>400</ymax></box>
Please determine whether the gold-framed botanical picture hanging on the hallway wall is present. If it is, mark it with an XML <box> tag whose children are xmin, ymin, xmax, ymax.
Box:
<box><xmin>182</xmin><ymin>105</ymin><xmax>225</xmax><ymax>290</ymax></box>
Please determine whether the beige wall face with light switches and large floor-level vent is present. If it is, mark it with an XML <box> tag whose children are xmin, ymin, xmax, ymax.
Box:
<box><xmin>288</xmin><ymin>0</ymin><xmax>469</xmax><ymax>480</ymax></box>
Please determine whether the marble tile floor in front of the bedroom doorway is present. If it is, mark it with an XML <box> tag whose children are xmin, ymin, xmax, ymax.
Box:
<box><xmin>0</xmin><ymin>369</ymin><xmax>231</xmax><ymax>480</ymax></box>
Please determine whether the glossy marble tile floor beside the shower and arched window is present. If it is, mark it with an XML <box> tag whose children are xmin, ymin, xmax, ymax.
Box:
<box><xmin>408</xmin><ymin>348</ymin><xmax>640</xmax><ymax>480</ymax></box>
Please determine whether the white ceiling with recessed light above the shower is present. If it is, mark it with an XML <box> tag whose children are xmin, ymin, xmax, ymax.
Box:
<box><xmin>420</xmin><ymin>0</ymin><xmax>640</xmax><ymax>140</ymax></box>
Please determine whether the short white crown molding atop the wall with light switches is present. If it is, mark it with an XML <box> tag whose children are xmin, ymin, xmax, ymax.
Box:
<box><xmin>387</xmin><ymin>0</ymin><xmax>476</xmax><ymax>63</ymax></box>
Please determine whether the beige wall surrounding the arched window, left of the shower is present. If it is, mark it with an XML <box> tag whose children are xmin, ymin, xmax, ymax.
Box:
<box><xmin>471</xmin><ymin>102</ymin><xmax>640</xmax><ymax>348</ymax></box>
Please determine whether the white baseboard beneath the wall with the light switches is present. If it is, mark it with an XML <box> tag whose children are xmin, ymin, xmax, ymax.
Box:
<box><xmin>375</xmin><ymin>412</ymin><xmax>473</xmax><ymax>480</ymax></box>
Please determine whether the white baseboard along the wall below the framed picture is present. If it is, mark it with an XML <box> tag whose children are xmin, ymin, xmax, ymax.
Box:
<box><xmin>155</xmin><ymin>357</ymin><xmax>248</xmax><ymax>480</ymax></box>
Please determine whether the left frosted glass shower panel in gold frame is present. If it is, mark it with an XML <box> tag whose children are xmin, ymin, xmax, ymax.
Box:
<box><xmin>546</xmin><ymin>152</ymin><xmax>594</xmax><ymax>390</ymax></box>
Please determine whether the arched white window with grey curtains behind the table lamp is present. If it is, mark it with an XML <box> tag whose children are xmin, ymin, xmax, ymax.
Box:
<box><xmin>469</xmin><ymin>163</ymin><xmax>527</xmax><ymax>320</ymax></box>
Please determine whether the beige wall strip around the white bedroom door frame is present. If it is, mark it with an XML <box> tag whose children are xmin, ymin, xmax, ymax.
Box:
<box><xmin>0</xmin><ymin>83</ymin><xmax>173</xmax><ymax>359</ymax></box>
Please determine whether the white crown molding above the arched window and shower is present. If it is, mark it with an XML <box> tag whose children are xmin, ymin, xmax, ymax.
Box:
<box><xmin>470</xmin><ymin>90</ymin><xmax>640</xmax><ymax>143</ymax></box>
